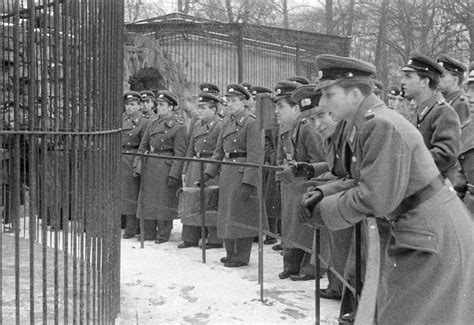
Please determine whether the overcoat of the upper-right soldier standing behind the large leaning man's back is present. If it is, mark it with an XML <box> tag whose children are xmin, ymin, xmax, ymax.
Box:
<box><xmin>415</xmin><ymin>93</ymin><xmax>461</xmax><ymax>176</ymax></box>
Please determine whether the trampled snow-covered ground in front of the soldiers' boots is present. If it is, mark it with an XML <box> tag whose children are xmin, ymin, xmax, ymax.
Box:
<box><xmin>117</xmin><ymin>220</ymin><xmax>339</xmax><ymax>324</ymax></box>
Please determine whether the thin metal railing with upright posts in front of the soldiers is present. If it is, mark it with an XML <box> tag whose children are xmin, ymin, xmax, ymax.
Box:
<box><xmin>122</xmin><ymin>151</ymin><xmax>380</xmax><ymax>324</ymax></box>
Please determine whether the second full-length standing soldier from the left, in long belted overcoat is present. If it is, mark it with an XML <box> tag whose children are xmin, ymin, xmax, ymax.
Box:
<box><xmin>137</xmin><ymin>90</ymin><xmax>187</xmax><ymax>244</ymax></box>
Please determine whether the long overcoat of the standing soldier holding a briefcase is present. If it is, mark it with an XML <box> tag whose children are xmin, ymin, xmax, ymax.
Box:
<box><xmin>181</xmin><ymin>115</ymin><xmax>222</xmax><ymax>227</ymax></box>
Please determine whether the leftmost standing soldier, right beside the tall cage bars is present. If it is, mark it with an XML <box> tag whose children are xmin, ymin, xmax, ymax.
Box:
<box><xmin>120</xmin><ymin>91</ymin><xmax>148</xmax><ymax>239</ymax></box>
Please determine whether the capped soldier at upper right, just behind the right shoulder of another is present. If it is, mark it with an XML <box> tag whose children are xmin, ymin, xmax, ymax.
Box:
<box><xmin>438</xmin><ymin>54</ymin><xmax>469</xmax><ymax>127</ymax></box>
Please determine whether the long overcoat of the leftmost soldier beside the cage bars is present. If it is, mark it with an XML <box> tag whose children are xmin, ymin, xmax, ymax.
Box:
<box><xmin>119</xmin><ymin>112</ymin><xmax>148</xmax><ymax>215</ymax></box>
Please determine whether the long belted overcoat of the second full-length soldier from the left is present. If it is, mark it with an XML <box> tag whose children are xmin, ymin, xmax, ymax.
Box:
<box><xmin>137</xmin><ymin>114</ymin><xmax>187</xmax><ymax>220</ymax></box>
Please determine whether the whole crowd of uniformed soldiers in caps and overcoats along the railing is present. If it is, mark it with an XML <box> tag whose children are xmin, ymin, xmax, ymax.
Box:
<box><xmin>120</xmin><ymin>54</ymin><xmax>474</xmax><ymax>324</ymax></box>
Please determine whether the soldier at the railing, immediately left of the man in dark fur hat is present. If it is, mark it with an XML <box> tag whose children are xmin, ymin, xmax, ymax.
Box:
<box><xmin>274</xmin><ymin>80</ymin><xmax>325</xmax><ymax>281</ymax></box>
